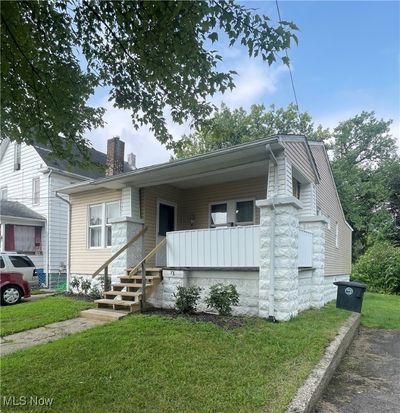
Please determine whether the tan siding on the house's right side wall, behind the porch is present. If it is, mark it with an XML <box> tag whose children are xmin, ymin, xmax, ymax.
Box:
<box><xmin>311</xmin><ymin>145</ymin><xmax>352</xmax><ymax>275</ymax></box>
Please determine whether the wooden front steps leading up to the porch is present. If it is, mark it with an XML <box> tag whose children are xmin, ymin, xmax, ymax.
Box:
<box><xmin>81</xmin><ymin>268</ymin><xmax>162</xmax><ymax>320</ymax></box>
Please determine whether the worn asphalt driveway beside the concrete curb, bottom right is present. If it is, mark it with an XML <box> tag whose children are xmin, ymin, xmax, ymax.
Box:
<box><xmin>315</xmin><ymin>328</ymin><xmax>400</xmax><ymax>413</ymax></box>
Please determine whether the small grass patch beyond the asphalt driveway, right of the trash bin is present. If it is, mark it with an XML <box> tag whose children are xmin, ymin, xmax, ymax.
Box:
<box><xmin>361</xmin><ymin>293</ymin><xmax>400</xmax><ymax>329</ymax></box>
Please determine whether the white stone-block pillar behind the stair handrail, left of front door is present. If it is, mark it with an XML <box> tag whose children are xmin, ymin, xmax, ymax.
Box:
<box><xmin>111</xmin><ymin>217</ymin><xmax>143</xmax><ymax>282</ymax></box>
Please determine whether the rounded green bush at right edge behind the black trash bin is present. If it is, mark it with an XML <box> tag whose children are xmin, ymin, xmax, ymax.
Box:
<box><xmin>352</xmin><ymin>241</ymin><xmax>400</xmax><ymax>294</ymax></box>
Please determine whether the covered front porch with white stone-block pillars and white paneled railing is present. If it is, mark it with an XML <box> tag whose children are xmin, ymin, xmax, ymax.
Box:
<box><xmin>99</xmin><ymin>138</ymin><xmax>327</xmax><ymax>320</ymax></box>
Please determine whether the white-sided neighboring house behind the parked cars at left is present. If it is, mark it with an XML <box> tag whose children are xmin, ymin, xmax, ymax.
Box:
<box><xmin>0</xmin><ymin>138</ymin><xmax>132</xmax><ymax>287</ymax></box>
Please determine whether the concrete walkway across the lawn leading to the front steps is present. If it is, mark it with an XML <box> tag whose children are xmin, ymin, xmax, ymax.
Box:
<box><xmin>0</xmin><ymin>317</ymin><xmax>107</xmax><ymax>356</ymax></box>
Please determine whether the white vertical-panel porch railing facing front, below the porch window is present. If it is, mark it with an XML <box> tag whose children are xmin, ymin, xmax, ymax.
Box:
<box><xmin>167</xmin><ymin>225</ymin><xmax>260</xmax><ymax>268</ymax></box>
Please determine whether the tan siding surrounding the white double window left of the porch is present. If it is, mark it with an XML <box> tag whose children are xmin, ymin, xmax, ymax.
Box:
<box><xmin>70</xmin><ymin>189</ymin><xmax>121</xmax><ymax>274</ymax></box>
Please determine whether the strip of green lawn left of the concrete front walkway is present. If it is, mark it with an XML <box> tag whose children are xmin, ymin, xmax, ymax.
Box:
<box><xmin>0</xmin><ymin>296</ymin><xmax>94</xmax><ymax>337</ymax></box>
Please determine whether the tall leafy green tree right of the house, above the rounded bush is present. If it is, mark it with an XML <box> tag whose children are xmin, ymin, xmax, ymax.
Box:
<box><xmin>332</xmin><ymin>112</ymin><xmax>400</xmax><ymax>259</ymax></box>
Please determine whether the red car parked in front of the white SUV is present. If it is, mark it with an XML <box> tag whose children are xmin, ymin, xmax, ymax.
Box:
<box><xmin>0</xmin><ymin>271</ymin><xmax>31</xmax><ymax>305</ymax></box>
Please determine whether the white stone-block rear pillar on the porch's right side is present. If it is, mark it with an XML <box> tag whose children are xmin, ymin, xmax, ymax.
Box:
<box><xmin>300</xmin><ymin>215</ymin><xmax>328</xmax><ymax>308</ymax></box>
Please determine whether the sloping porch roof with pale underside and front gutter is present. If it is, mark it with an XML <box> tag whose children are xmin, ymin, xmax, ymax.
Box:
<box><xmin>58</xmin><ymin>135</ymin><xmax>300</xmax><ymax>194</ymax></box>
